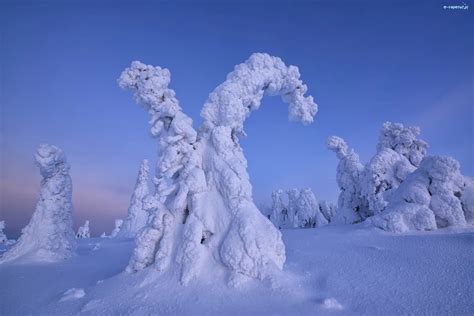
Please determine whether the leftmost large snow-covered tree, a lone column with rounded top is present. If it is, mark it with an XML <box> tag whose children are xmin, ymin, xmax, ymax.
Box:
<box><xmin>0</xmin><ymin>145</ymin><xmax>76</xmax><ymax>262</ymax></box>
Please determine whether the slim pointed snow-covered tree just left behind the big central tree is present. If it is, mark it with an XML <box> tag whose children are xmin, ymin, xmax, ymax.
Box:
<box><xmin>117</xmin><ymin>159</ymin><xmax>150</xmax><ymax>238</ymax></box>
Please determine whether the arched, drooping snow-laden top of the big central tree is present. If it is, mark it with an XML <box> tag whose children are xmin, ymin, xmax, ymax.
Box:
<box><xmin>201</xmin><ymin>53</ymin><xmax>318</xmax><ymax>135</ymax></box>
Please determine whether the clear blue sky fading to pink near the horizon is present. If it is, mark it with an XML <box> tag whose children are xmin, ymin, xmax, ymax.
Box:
<box><xmin>0</xmin><ymin>0</ymin><xmax>474</xmax><ymax>236</ymax></box>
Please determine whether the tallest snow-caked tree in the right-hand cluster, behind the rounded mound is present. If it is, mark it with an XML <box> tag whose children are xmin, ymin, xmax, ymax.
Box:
<box><xmin>361</xmin><ymin>122</ymin><xmax>428</xmax><ymax>216</ymax></box>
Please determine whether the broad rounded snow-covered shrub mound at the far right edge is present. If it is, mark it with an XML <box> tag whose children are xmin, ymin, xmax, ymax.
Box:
<box><xmin>371</xmin><ymin>156</ymin><xmax>469</xmax><ymax>232</ymax></box>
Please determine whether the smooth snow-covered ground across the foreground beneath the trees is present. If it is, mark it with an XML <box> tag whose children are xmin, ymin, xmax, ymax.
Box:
<box><xmin>0</xmin><ymin>224</ymin><xmax>474</xmax><ymax>315</ymax></box>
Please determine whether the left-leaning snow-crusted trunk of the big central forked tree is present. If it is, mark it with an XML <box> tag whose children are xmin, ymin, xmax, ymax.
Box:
<box><xmin>118</xmin><ymin>61</ymin><xmax>206</xmax><ymax>282</ymax></box>
